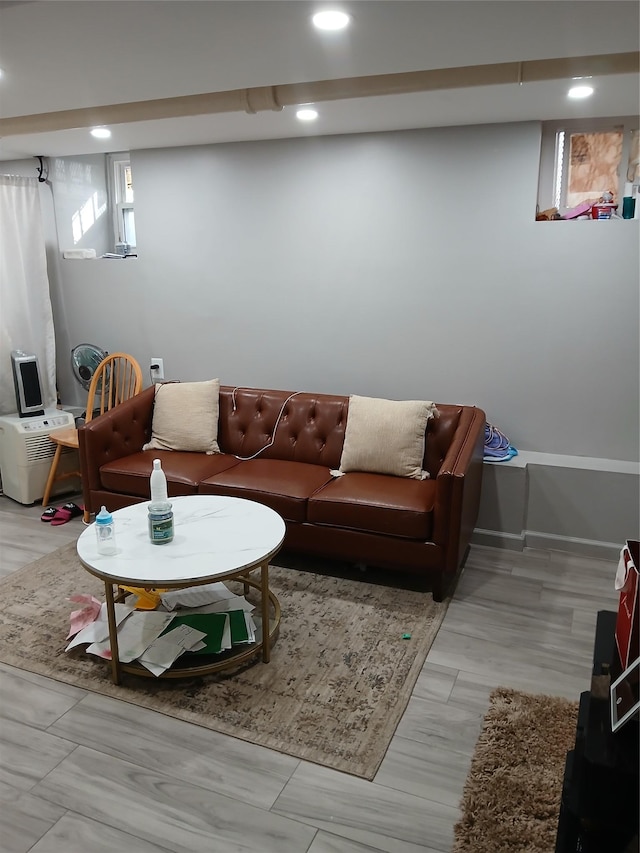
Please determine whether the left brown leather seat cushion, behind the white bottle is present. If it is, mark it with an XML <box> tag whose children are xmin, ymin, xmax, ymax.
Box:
<box><xmin>100</xmin><ymin>450</ymin><xmax>238</xmax><ymax>499</ymax></box>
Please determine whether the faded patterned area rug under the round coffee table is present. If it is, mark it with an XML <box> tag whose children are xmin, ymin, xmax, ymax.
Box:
<box><xmin>0</xmin><ymin>543</ymin><xmax>447</xmax><ymax>779</ymax></box>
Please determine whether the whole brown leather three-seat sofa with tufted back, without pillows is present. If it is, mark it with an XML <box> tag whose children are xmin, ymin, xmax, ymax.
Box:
<box><xmin>79</xmin><ymin>386</ymin><xmax>485</xmax><ymax>601</ymax></box>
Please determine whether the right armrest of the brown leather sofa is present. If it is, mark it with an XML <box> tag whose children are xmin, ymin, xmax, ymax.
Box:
<box><xmin>433</xmin><ymin>406</ymin><xmax>486</xmax><ymax>572</ymax></box>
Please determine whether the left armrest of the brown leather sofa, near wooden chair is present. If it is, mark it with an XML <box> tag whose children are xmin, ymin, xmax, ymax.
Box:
<box><xmin>78</xmin><ymin>386</ymin><xmax>155</xmax><ymax>512</ymax></box>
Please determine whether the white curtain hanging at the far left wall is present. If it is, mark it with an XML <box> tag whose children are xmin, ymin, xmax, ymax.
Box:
<box><xmin>0</xmin><ymin>175</ymin><xmax>56</xmax><ymax>415</ymax></box>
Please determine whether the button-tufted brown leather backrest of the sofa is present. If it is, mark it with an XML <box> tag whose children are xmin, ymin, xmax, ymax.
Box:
<box><xmin>218</xmin><ymin>385</ymin><xmax>461</xmax><ymax>477</ymax></box>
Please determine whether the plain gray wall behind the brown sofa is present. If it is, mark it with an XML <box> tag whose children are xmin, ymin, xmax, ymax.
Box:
<box><xmin>53</xmin><ymin>123</ymin><xmax>640</xmax><ymax>461</ymax></box>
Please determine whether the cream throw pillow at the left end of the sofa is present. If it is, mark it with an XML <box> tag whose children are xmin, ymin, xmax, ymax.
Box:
<box><xmin>142</xmin><ymin>379</ymin><xmax>220</xmax><ymax>454</ymax></box>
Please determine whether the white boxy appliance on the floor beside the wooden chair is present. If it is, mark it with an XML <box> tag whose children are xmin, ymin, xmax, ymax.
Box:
<box><xmin>0</xmin><ymin>409</ymin><xmax>80</xmax><ymax>504</ymax></box>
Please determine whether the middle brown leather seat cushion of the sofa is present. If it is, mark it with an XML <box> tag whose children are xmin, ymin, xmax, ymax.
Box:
<box><xmin>199</xmin><ymin>459</ymin><xmax>331</xmax><ymax>522</ymax></box>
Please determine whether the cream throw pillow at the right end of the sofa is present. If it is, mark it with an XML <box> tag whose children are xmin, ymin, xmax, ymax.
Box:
<box><xmin>331</xmin><ymin>395</ymin><xmax>437</xmax><ymax>480</ymax></box>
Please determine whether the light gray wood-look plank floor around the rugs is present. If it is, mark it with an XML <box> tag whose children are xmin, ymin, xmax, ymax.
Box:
<box><xmin>0</xmin><ymin>497</ymin><xmax>622</xmax><ymax>853</ymax></box>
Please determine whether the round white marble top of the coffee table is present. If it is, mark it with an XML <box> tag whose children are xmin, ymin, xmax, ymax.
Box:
<box><xmin>77</xmin><ymin>495</ymin><xmax>285</xmax><ymax>587</ymax></box>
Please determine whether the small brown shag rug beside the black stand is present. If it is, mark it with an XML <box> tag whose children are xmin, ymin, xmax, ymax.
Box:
<box><xmin>452</xmin><ymin>687</ymin><xmax>578</xmax><ymax>853</ymax></box>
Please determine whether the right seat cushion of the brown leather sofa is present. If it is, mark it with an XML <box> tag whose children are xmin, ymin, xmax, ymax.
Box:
<box><xmin>307</xmin><ymin>472</ymin><xmax>436</xmax><ymax>541</ymax></box>
